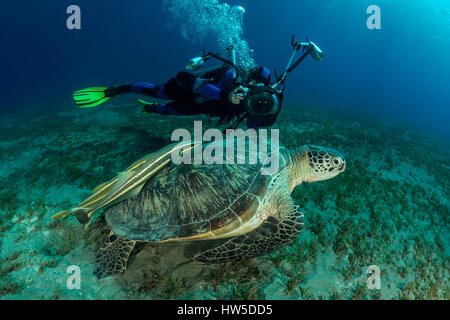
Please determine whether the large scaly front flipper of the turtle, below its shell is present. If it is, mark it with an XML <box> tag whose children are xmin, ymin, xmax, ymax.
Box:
<box><xmin>194</xmin><ymin>205</ymin><xmax>303</xmax><ymax>263</ymax></box>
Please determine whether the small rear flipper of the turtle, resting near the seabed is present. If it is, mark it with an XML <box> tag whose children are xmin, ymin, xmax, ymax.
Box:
<box><xmin>94</xmin><ymin>232</ymin><xmax>136</xmax><ymax>279</ymax></box>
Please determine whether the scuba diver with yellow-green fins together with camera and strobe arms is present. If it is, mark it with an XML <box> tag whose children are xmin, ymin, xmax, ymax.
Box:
<box><xmin>73</xmin><ymin>37</ymin><xmax>323</xmax><ymax>129</ymax></box>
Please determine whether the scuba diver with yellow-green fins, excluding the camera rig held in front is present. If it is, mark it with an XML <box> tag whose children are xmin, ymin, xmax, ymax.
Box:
<box><xmin>74</xmin><ymin>65</ymin><xmax>276</xmax><ymax>129</ymax></box>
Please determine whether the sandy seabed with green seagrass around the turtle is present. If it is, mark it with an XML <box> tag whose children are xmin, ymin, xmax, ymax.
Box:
<box><xmin>0</xmin><ymin>104</ymin><xmax>450</xmax><ymax>299</ymax></box>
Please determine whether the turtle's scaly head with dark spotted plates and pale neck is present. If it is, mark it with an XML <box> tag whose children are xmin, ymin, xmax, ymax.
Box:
<box><xmin>292</xmin><ymin>145</ymin><xmax>346</xmax><ymax>187</ymax></box>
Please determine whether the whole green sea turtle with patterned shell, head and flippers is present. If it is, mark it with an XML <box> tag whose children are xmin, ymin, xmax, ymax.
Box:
<box><xmin>94</xmin><ymin>139</ymin><xmax>345</xmax><ymax>278</ymax></box>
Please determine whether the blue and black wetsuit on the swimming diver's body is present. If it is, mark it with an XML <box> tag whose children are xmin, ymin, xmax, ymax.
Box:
<box><xmin>130</xmin><ymin>68</ymin><xmax>257</xmax><ymax>129</ymax></box>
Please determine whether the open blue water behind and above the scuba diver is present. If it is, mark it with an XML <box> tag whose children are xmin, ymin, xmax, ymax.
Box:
<box><xmin>0</xmin><ymin>0</ymin><xmax>450</xmax><ymax>141</ymax></box>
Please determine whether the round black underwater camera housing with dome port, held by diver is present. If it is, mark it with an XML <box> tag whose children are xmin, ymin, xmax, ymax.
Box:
<box><xmin>244</xmin><ymin>86</ymin><xmax>283</xmax><ymax>127</ymax></box>
